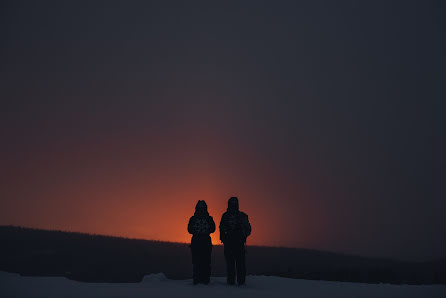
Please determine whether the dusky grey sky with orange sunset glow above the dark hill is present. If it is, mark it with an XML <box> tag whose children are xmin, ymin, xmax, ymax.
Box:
<box><xmin>0</xmin><ymin>0</ymin><xmax>446</xmax><ymax>260</ymax></box>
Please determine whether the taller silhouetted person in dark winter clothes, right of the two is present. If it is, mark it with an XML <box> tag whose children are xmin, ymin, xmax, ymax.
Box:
<box><xmin>220</xmin><ymin>197</ymin><xmax>251</xmax><ymax>285</ymax></box>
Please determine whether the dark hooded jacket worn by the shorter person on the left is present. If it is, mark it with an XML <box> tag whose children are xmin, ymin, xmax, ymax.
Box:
<box><xmin>187</xmin><ymin>200</ymin><xmax>215</xmax><ymax>237</ymax></box>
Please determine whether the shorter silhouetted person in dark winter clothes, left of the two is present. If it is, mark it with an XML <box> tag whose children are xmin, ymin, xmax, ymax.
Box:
<box><xmin>187</xmin><ymin>201</ymin><xmax>215</xmax><ymax>284</ymax></box>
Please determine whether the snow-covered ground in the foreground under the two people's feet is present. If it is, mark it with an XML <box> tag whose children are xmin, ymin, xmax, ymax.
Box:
<box><xmin>0</xmin><ymin>272</ymin><xmax>446</xmax><ymax>298</ymax></box>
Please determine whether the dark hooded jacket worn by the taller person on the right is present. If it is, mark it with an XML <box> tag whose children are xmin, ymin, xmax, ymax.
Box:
<box><xmin>220</xmin><ymin>197</ymin><xmax>251</xmax><ymax>243</ymax></box>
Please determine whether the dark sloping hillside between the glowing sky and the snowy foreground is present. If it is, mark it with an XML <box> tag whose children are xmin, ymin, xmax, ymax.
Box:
<box><xmin>0</xmin><ymin>226</ymin><xmax>446</xmax><ymax>284</ymax></box>
